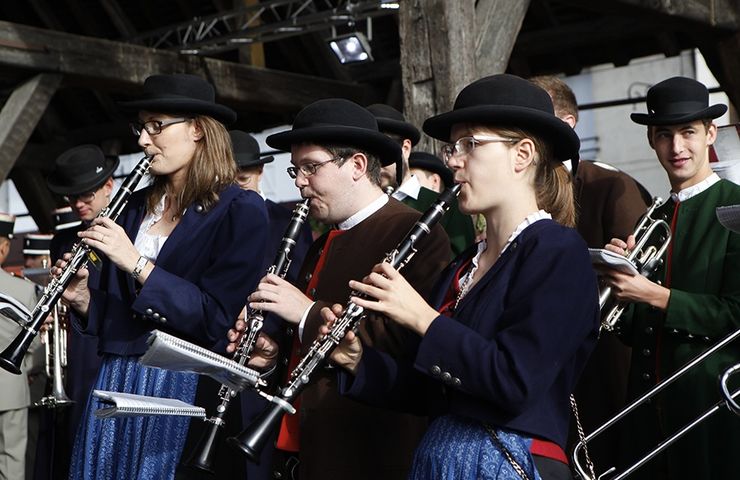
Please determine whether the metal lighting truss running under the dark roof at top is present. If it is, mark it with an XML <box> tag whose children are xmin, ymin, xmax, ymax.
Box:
<box><xmin>128</xmin><ymin>0</ymin><xmax>398</xmax><ymax>55</ymax></box>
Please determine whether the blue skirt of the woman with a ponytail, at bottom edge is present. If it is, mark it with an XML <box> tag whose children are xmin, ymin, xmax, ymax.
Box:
<box><xmin>409</xmin><ymin>415</ymin><xmax>541</xmax><ymax>480</ymax></box>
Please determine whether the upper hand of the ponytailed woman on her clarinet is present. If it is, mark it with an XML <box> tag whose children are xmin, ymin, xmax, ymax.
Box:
<box><xmin>349</xmin><ymin>262</ymin><xmax>439</xmax><ymax>335</ymax></box>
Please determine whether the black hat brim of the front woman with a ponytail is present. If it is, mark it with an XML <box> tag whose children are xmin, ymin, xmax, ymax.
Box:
<box><xmin>423</xmin><ymin>105</ymin><xmax>581</xmax><ymax>172</ymax></box>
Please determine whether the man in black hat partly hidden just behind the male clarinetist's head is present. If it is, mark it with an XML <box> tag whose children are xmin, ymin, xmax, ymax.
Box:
<box><xmin>367</xmin><ymin>103</ymin><xmax>475</xmax><ymax>256</ymax></box>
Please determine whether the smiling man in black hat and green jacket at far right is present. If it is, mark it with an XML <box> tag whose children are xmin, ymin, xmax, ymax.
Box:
<box><xmin>605</xmin><ymin>77</ymin><xmax>740</xmax><ymax>478</ymax></box>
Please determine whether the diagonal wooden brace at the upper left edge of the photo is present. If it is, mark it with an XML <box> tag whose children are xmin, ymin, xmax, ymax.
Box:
<box><xmin>0</xmin><ymin>73</ymin><xmax>62</xmax><ymax>181</ymax></box>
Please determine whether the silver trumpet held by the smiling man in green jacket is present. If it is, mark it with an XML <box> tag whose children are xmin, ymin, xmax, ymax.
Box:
<box><xmin>599</xmin><ymin>197</ymin><xmax>673</xmax><ymax>332</ymax></box>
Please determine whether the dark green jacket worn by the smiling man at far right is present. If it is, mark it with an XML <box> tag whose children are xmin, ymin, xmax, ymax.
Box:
<box><xmin>626</xmin><ymin>180</ymin><xmax>740</xmax><ymax>478</ymax></box>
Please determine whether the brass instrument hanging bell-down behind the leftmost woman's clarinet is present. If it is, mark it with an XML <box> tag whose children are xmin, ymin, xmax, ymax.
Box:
<box><xmin>36</xmin><ymin>302</ymin><xmax>73</xmax><ymax>408</ymax></box>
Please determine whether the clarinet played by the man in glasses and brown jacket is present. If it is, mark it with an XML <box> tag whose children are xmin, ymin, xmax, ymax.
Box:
<box><xmin>186</xmin><ymin>199</ymin><xmax>310</xmax><ymax>473</ymax></box>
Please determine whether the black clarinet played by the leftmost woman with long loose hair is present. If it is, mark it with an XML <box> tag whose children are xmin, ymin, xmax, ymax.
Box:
<box><xmin>0</xmin><ymin>156</ymin><xmax>152</xmax><ymax>375</ymax></box>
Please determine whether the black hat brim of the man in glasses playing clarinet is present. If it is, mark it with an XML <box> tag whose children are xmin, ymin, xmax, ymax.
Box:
<box><xmin>266</xmin><ymin>125</ymin><xmax>402</xmax><ymax>167</ymax></box>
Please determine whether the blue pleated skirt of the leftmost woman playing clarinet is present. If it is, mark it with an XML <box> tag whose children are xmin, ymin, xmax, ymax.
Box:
<box><xmin>69</xmin><ymin>355</ymin><xmax>198</xmax><ymax>480</ymax></box>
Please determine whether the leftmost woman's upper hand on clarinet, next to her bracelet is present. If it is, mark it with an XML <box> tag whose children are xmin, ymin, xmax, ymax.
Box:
<box><xmin>77</xmin><ymin>217</ymin><xmax>141</xmax><ymax>273</ymax></box>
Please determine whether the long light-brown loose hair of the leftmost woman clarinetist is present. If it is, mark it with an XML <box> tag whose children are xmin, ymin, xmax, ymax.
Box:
<box><xmin>147</xmin><ymin>116</ymin><xmax>236</xmax><ymax>215</ymax></box>
